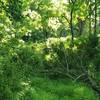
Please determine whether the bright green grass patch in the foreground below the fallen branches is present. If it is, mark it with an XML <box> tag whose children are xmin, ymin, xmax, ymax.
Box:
<box><xmin>17</xmin><ymin>77</ymin><xmax>99</xmax><ymax>100</ymax></box>
